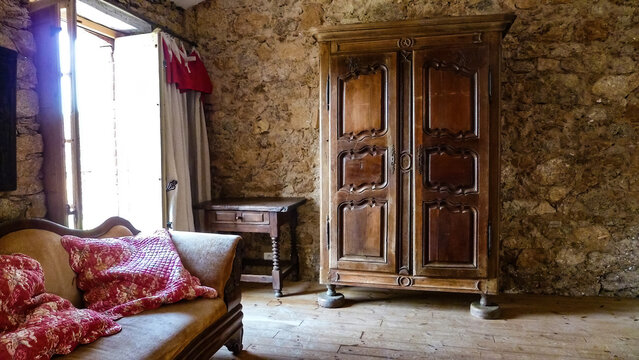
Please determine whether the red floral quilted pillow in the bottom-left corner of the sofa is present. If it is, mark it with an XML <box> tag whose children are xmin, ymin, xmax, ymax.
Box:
<box><xmin>0</xmin><ymin>254</ymin><xmax>121</xmax><ymax>360</ymax></box>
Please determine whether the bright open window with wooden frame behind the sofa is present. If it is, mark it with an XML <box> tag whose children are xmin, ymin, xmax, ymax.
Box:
<box><xmin>34</xmin><ymin>0</ymin><xmax>163</xmax><ymax>229</ymax></box>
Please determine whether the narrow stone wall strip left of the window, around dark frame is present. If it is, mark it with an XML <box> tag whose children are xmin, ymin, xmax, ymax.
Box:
<box><xmin>0</xmin><ymin>0</ymin><xmax>46</xmax><ymax>222</ymax></box>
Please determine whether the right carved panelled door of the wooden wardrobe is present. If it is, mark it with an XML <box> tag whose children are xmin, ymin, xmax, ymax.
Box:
<box><xmin>414</xmin><ymin>45</ymin><xmax>490</xmax><ymax>278</ymax></box>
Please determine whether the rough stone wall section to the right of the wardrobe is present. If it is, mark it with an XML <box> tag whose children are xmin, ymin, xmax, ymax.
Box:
<box><xmin>501</xmin><ymin>0</ymin><xmax>639</xmax><ymax>296</ymax></box>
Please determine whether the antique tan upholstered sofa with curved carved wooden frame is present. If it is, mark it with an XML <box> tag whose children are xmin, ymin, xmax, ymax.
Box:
<box><xmin>0</xmin><ymin>217</ymin><xmax>243</xmax><ymax>360</ymax></box>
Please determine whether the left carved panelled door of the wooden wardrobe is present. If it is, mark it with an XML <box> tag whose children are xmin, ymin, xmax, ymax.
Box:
<box><xmin>328</xmin><ymin>53</ymin><xmax>397</xmax><ymax>272</ymax></box>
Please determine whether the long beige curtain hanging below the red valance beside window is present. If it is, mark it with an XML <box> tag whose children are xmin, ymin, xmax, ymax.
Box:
<box><xmin>160</xmin><ymin>34</ymin><xmax>211</xmax><ymax>231</ymax></box>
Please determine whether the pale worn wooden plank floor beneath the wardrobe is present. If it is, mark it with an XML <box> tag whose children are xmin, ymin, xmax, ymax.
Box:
<box><xmin>214</xmin><ymin>282</ymin><xmax>639</xmax><ymax>360</ymax></box>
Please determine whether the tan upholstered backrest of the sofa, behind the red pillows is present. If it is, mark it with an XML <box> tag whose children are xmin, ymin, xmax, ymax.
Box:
<box><xmin>0</xmin><ymin>225</ymin><xmax>131</xmax><ymax>308</ymax></box>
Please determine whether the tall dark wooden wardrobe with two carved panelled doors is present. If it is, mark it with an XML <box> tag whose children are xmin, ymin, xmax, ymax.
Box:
<box><xmin>314</xmin><ymin>14</ymin><xmax>515</xmax><ymax>318</ymax></box>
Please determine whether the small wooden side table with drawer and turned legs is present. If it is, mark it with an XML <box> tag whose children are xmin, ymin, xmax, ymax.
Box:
<box><xmin>195</xmin><ymin>197</ymin><xmax>306</xmax><ymax>297</ymax></box>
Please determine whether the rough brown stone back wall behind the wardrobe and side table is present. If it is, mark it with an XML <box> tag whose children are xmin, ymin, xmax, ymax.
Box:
<box><xmin>199</xmin><ymin>0</ymin><xmax>639</xmax><ymax>296</ymax></box>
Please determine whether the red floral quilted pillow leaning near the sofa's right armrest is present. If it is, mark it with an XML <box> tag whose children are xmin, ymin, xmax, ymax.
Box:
<box><xmin>61</xmin><ymin>230</ymin><xmax>217</xmax><ymax>319</ymax></box>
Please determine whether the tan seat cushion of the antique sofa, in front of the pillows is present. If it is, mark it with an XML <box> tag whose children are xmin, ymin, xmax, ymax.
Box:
<box><xmin>61</xmin><ymin>298</ymin><xmax>226</xmax><ymax>360</ymax></box>
